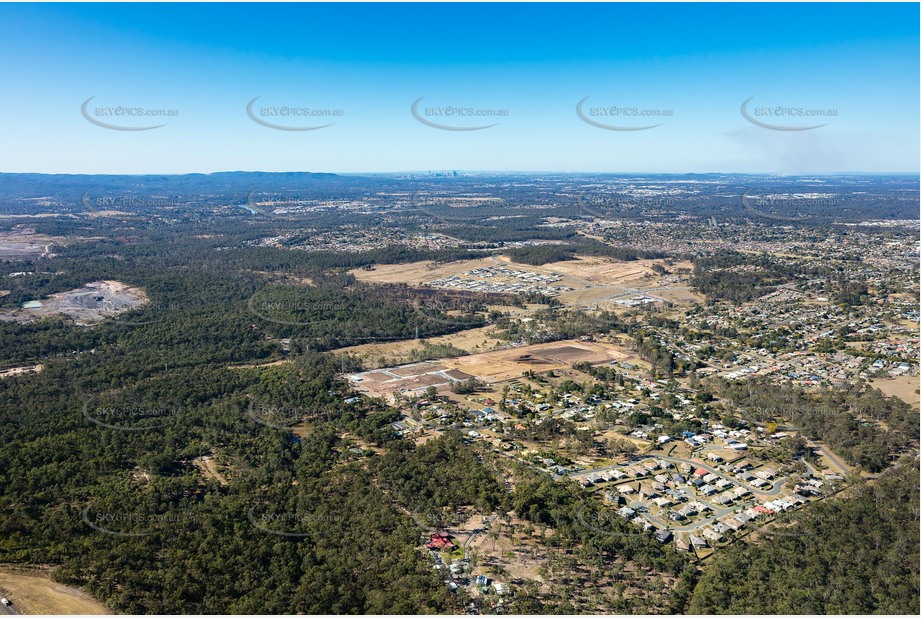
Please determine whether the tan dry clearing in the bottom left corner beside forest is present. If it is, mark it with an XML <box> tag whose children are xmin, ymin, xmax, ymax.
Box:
<box><xmin>0</xmin><ymin>566</ymin><xmax>112</xmax><ymax>614</ymax></box>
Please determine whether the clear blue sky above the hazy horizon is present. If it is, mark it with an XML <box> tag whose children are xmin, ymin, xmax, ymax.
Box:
<box><xmin>0</xmin><ymin>4</ymin><xmax>921</xmax><ymax>174</ymax></box>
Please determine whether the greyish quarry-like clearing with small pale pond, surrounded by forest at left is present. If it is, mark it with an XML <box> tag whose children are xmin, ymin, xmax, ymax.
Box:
<box><xmin>0</xmin><ymin>281</ymin><xmax>149</xmax><ymax>326</ymax></box>
